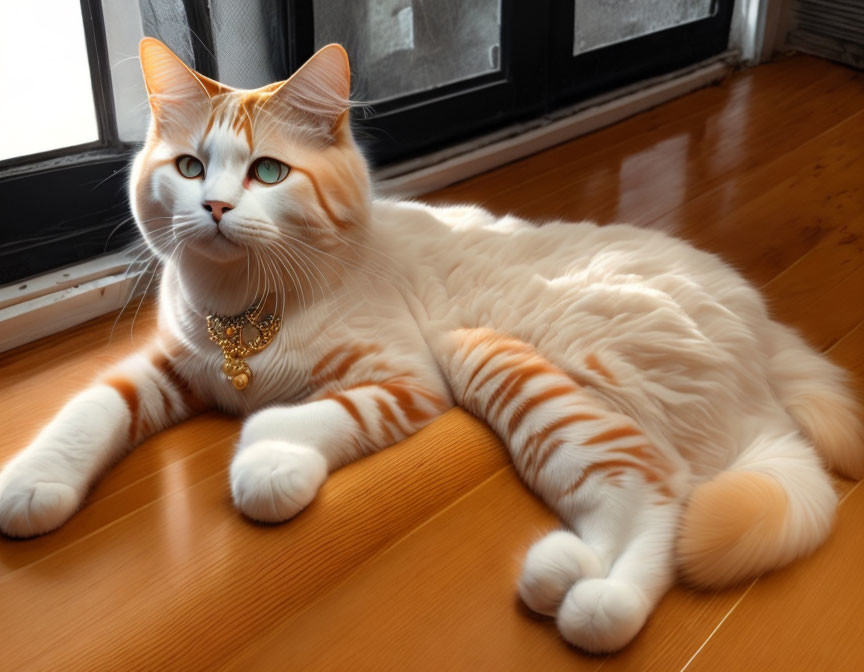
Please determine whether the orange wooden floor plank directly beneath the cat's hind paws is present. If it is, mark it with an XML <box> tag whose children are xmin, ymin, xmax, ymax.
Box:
<box><xmin>226</xmin><ymin>467</ymin><xmax>756</xmax><ymax>671</ymax></box>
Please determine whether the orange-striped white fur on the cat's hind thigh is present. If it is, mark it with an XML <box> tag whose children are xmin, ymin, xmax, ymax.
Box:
<box><xmin>454</xmin><ymin>329</ymin><xmax>674</xmax><ymax>500</ymax></box>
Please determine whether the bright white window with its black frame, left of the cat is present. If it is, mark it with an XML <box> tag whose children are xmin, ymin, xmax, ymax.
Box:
<box><xmin>0</xmin><ymin>0</ymin><xmax>129</xmax><ymax>284</ymax></box>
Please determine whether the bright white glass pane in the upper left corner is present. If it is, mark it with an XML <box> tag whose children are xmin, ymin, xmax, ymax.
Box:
<box><xmin>0</xmin><ymin>0</ymin><xmax>99</xmax><ymax>160</ymax></box>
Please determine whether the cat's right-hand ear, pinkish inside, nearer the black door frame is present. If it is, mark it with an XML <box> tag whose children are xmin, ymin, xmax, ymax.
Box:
<box><xmin>265</xmin><ymin>44</ymin><xmax>351</xmax><ymax>134</ymax></box>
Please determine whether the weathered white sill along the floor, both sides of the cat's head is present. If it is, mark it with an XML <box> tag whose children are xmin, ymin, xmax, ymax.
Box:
<box><xmin>0</xmin><ymin>52</ymin><xmax>737</xmax><ymax>352</ymax></box>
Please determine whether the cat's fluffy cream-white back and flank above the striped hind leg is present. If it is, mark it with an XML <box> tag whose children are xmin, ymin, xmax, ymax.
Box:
<box><xmin>375</xmin><ymin>203</ymin><xmax>770</xmax><ymax>466</ymax></box>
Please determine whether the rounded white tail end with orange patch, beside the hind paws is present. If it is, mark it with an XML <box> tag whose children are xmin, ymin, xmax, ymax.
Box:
<box><xmin>677</xmin><ymin>432</ymin><xmax>837</xmax><ymax>588</ymax></box>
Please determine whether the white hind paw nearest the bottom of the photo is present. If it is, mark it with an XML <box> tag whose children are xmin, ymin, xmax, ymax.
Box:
<box><xmin>558</xmin><ymin>579</ymin><xmax>648</xmax><ymax>653</ymax></box>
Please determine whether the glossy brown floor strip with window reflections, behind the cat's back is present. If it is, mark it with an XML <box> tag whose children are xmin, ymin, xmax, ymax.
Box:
<box><xmin>429</xmin><ymin>58</ymin><xmax>864</xmax><ymax>230</ymax></box>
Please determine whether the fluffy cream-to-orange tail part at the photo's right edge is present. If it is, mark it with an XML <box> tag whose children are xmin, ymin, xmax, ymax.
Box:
<box><xmin>769</xmin><ymin>325</ymin><xmax>864</xmax><ymax>480</ymax></box>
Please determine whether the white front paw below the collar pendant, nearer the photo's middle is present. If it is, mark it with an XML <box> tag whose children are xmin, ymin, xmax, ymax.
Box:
<box><xmin>231</xmin><ymin>441</ymin><xmax>327</xmax><ymax>523</ymax></box>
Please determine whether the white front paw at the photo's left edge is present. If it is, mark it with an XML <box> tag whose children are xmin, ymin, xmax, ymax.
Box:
<box><xmin>0</xmin><ymin>469</ymin><xmax>82</xmax><ymax>537</ymax></box>
